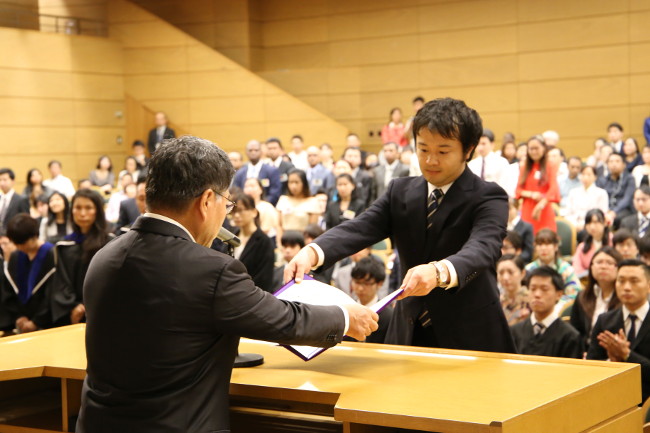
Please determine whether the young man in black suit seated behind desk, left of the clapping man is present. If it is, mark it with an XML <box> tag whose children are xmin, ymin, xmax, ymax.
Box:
<box><xmin>510</xmin><ymin>266</ymin><xmax>583</xmax><ymax>358</ymax></box>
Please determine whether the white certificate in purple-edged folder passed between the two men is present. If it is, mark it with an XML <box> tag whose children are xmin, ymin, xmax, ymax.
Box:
<box><xmin>274</xmin><ymin>275</ymin><xmax>402</xmax><ymax>361</ymax></box>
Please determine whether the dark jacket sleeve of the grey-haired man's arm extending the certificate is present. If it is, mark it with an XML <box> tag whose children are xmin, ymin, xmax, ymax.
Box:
<box><xmin>213</xmin><ymin>260</ymin><xmax>345</xmax><ymax>347</ymax></box>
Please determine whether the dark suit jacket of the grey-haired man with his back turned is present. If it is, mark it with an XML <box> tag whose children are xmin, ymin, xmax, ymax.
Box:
<box><xmin>76</xmin><ymin>217</ymin><xmax>344</xmax><ymax>433</ymax></box>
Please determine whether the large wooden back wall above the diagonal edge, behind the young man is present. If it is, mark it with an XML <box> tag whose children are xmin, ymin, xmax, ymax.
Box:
<box><xmin>128</xmin><ymin>0</ymin><xmax>650</xmax><ymax>156</ymax></box>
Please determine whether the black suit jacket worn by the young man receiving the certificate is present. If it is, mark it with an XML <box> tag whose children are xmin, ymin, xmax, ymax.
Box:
<box><xmin>316</xmin><ymin>168</ymin><xmax>515</xmax><ymax>352</ymax></box>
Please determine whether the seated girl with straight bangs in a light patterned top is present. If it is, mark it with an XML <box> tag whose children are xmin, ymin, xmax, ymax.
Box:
<box><xmin>526</xmin><ymin>229</ymin><xmax>582</xmax><ymax>299</ymax></box>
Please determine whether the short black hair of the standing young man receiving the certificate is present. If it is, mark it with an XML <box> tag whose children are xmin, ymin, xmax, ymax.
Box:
<box><xmin>413</xmin><ymin>98</ymin><xmax>483</xmax><ymax>161</ymax></box>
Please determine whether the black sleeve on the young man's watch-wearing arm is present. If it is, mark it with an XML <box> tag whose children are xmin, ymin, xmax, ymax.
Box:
<box><xmin>447</xmin><ymin>183</ymin><xmax>508</xmax><ymax>289</ymax></box>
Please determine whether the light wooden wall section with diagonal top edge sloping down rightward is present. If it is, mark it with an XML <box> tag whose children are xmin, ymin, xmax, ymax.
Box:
<box><xmin>109</xmin><ymin>0</ymin><xmax>347</xmax><ymax>154</ymax></box>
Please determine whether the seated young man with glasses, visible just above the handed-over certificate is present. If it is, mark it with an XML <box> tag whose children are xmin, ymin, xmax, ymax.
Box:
<box><xmin>350</xmin><ymin>257</ymin><xmax>393</xmax><ymax>343</ymax></box>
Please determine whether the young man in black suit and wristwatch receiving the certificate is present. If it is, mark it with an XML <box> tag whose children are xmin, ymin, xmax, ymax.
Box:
<box><xmin>284</xmin><ymin>98</ymin><xmax>515</xmax><ymax>352</ymax></box>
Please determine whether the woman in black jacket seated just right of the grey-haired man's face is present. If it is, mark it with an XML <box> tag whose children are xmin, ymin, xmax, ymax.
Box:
<box><xmin>231</xmin><ymin>193</ymin><xmax>280</xmax><ymax>292</ymax></box>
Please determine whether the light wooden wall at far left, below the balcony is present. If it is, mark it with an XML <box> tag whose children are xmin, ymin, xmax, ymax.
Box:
<box><xmin>0</xmin><ymin>28</ymin><xmax>125</xmax><ymax>189</ymax></box>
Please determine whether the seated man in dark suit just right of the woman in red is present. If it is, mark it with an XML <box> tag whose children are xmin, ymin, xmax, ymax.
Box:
<box><xmin>596</xmin><ymin>153</ymin><xmax>634</xmax><ymax>228</ymax></box>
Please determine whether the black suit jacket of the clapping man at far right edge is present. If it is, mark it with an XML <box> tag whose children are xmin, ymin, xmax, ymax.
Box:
<box><xmin>587</xmin><ymin>307</ymin><xmax>650</xmax><ymax>401</ymax></box>
